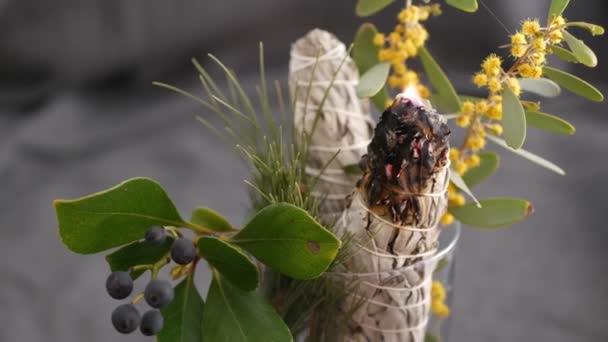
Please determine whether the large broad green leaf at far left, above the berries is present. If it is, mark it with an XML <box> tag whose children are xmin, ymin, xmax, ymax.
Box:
<box><xmin>54</xmin><ymin>178</ymin><xmax>191</xmax><ymax>254</ymax></box>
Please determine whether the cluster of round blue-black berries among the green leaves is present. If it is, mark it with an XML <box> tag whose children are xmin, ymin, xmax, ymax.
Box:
<box><xmin>106</xmin><ymin>227</ymin><xmax>196</xmax><ymax>336</ymax></box>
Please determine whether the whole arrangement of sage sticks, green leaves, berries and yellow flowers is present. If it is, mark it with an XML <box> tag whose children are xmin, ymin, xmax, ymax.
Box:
<box><xmin>55</xmin><ymin>0</ymin><xmax>604</xmax><ymax>342</ymax></box>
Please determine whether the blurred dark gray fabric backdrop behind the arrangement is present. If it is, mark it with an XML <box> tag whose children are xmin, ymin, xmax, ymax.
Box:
<box><xmin>0</xmin><ymin>0</ymin><xmax>608</xmax><ymax>342</ymax></box>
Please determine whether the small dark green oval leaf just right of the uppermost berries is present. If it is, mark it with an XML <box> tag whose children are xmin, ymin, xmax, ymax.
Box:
<box><xmin>198</xmin><ymin>236</ymin><xmax>260</xmax><ymax>291</ymax></box>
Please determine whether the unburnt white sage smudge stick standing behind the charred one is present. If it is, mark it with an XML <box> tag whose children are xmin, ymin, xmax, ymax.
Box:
<box><xmin>289</xmin><ymin>29</ymin><xmax>375</xmax><ymax>223</ymax></box>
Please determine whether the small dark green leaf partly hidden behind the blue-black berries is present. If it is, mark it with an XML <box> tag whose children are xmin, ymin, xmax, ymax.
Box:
<box><xmin>106</xmin><ymin>237</ymin><xmax>173</xmax><ymax>280</ymax></box>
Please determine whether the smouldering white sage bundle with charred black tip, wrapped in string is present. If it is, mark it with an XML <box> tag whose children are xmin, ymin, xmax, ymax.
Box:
<box><xmin>330</xmin><ymin>91</ymin><xmax>450</xmax><ymax>342</ymax></box>
